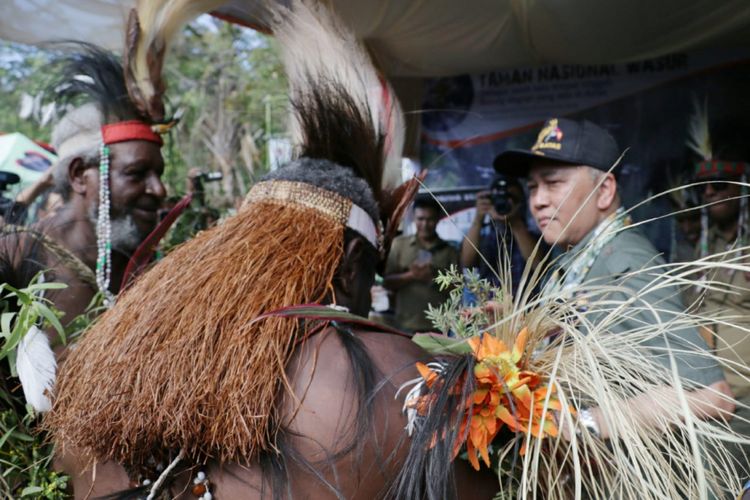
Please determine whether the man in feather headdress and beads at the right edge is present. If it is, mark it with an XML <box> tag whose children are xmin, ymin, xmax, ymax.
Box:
<box><xmin>687</xmin><ymin>106</ymin><xmax>750</xmax><ymax>479</ymax></box>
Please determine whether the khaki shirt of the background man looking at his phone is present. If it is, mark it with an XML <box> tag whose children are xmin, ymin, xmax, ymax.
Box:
<box><xmin>385</xmin><ymin>235</ymin><xmax>458</xmax><ymax>332</ymax></box>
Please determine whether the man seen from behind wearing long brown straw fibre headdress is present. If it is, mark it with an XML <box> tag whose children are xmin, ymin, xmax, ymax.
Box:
<box><xmin>46</xmin><ymin>2</ymin><xmax>506</xmax><ymax>499</ymax></box>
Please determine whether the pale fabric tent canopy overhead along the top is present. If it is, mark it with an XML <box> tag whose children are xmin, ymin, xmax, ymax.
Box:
<box><xmin>0</xmin><ymin>0</ymin><xmax>750</xmax><ymax>77</ymax></box>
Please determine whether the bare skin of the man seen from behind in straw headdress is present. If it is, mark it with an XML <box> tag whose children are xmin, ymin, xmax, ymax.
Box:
<box><xmin>61</xmin><ymin>237</ymin><xmax>498</xmax><ymax>500</ymax></box>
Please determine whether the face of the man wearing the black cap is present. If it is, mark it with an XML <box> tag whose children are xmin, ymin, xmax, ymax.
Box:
<box><xmin>528</xmin><ymin>162</ymin><xmax>599</xmax><ymax>248</ymax></box>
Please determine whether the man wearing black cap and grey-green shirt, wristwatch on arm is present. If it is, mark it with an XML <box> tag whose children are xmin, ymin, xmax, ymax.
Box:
<box><xmin>495</xmin><ymin>118</ymin><xmax>733</xmax><ymax>438</ymax></box>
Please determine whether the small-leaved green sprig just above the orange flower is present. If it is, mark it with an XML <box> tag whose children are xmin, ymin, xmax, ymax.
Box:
<box><xmin>427</xmin><ymin>265</ymin><xmax>501</xmax><ymax>339</ymax></box>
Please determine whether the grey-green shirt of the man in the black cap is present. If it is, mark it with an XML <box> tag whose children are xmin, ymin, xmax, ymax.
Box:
<box><xmin>562</xmin><ymin>229</ymin><xmax>724</xmax><ymax>385</ymax></box>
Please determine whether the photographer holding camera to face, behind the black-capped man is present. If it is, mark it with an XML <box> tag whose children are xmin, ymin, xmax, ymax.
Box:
<box><xmin>461</xmin><ymin>174</ymin><xmax>546</xmax><ymax>293</ymax></box>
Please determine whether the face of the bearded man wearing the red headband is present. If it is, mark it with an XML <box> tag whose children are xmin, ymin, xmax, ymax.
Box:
<box><xmin>89</xmin><ymin>140</ymin><xmax>166</xmax><ymax>250</ymax></box>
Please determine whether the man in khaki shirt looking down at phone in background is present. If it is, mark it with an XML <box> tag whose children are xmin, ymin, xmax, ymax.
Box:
<box><xmin>384</xmin><ymin>198</ymin><xmax>458</xmax><ymax>332</ymax></box>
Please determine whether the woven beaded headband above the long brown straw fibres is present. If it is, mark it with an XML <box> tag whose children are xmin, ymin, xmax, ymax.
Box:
<box><xmin>245</xmin><ymin>180</ymin><xmax>383</xmax><ymax>252</ymax></box>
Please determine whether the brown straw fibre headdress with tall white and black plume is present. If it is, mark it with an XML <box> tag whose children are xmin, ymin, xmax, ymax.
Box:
<box><xmin>48</xmin><ymin>2</ymin><xmax>416</xmax><ymax>463</ymax></box>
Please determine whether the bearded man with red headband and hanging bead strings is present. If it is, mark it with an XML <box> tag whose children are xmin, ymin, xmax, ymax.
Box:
<box><xmin>0</xmin><ymin>47</ymin><xmax>166</xmax><ymax>411</ymax></box>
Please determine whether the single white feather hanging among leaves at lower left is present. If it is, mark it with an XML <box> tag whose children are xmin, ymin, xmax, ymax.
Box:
<box><xmin>16</xmin><ymin>325</ymin><xmax>57</xmax><ymax>412</ymax></box>
